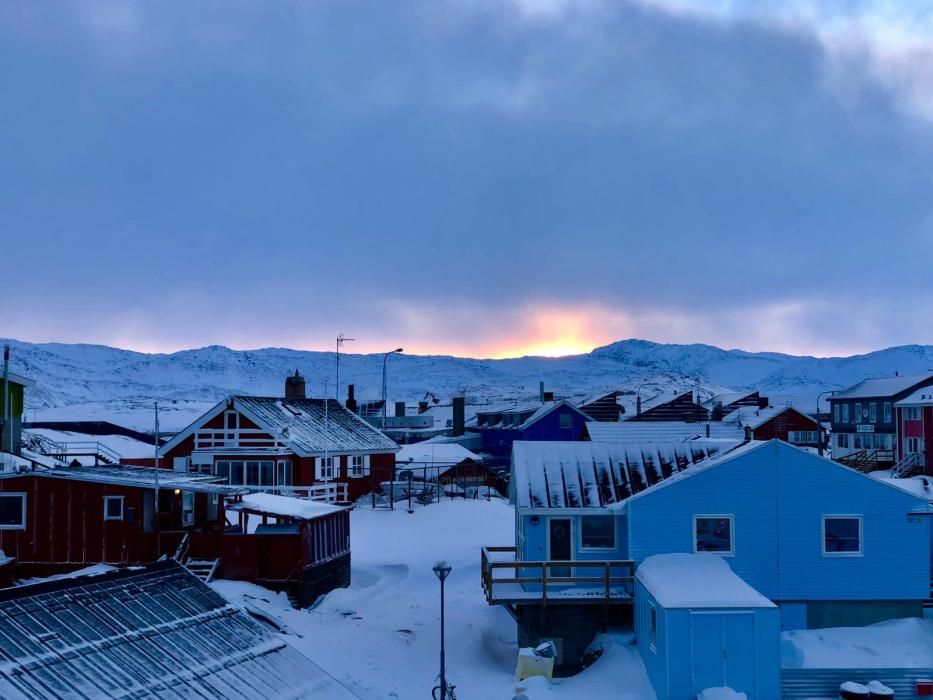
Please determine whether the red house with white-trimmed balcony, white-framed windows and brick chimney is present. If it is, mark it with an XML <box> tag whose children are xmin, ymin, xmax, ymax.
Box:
<box><xmin>159</xmin><ymin>372</ymin><xmax>399</xmax><ymax>503</ymax></box>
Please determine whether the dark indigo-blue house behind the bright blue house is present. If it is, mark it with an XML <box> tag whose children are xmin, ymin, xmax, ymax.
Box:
<box><xmin>467</xmin><ymin>401</ymin><xmax>593</xmax><ymax>463</ymax></box>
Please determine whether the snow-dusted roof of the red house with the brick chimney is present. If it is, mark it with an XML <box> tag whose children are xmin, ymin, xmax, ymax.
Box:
<box><xmin>233</xmin><ymin>396</ymin><xmax>398</xmax><ymax>455</ymax></box>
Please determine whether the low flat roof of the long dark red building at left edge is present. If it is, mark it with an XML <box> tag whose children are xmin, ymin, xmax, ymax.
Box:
<box><xmin>0</xmin><ymin>466</ymin><xmax>245</xmax><ymax>496</ymax></box>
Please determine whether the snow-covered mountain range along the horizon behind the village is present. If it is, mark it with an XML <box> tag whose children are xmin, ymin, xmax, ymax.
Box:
<box><xmin>10</xmin><ymin>340</ymin><xmax>933</xmax><ymax>430</ymax></box>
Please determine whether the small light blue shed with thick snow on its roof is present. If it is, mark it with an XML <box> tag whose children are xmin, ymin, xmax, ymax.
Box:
<box><xmin>635</xmin><ymin>554</ymin><xmax>781</xmax><ymax>700</ymax></box>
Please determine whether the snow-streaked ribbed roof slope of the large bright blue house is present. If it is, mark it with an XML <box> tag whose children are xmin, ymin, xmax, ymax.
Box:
<box><xmin>510</xmin><ymin>440</ymin><xmax>739</xmax><ymax>508</ymax></box>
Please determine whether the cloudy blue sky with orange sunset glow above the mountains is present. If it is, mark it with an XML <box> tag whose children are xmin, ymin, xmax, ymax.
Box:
<box><xmin>0</xmin><ymin>0</ymin><xmax>933</xmax><ymax>357</ymax></box>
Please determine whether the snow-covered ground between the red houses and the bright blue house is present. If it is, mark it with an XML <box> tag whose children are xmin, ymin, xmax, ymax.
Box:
<box><xmin>211</xmin><ymin>501</ymin><xmax>655</xmax><ymax>700</ymax></box>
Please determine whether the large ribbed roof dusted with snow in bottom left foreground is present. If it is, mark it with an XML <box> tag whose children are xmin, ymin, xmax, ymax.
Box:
<box><xmin>0</xmin><ymin>560</ymin><xmax>355</xmax><ymax>700</ymax></box>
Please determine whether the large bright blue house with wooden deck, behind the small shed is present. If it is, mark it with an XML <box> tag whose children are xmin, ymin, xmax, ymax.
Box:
<box><xmin>483</xmin><ymin>440</ymin><xmax>931</xmax><ymax>668</ymax></box>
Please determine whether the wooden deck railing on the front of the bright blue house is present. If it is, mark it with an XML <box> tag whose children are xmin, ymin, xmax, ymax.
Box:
<box><xmin>480</xmin><ymin>547</ymin><xmax>635</xmax><ymax>605</ymax></box>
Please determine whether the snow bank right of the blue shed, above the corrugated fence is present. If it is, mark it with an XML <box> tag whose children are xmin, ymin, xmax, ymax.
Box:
<box><xmin>781</xmin><ymin>618</ymin><xmax>933</xmax><ymax>668</ymax></box>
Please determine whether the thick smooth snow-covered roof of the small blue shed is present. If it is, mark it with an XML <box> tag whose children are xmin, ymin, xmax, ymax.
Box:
<box><xmin>635</xmin><ymin>552</ymin><xmax>776</xmax><ymax>608</ymax></box>
